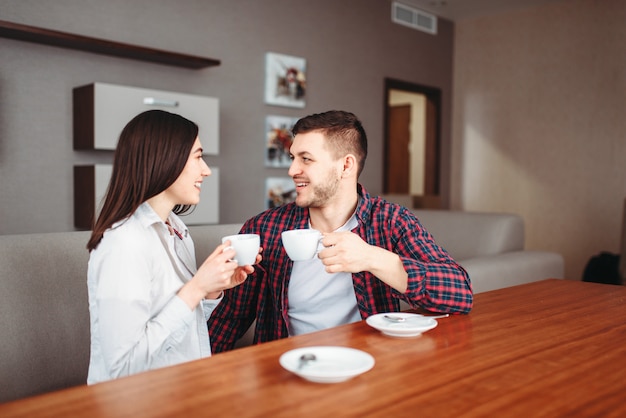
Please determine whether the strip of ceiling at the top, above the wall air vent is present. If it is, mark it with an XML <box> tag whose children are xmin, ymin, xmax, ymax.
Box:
<box><xmin>397</xmin><ymin>0</ymin><xmax>562</xmax><ymax>21</ymax></box>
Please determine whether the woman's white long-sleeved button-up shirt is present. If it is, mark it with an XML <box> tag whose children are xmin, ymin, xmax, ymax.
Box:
<box><xmin>87</xmin><ymin>203</ymin><xmax>221</xmax><ymax>384</ymax></box>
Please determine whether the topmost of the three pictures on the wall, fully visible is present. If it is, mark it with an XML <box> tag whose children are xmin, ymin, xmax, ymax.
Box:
<box><xmin>265</xmin><ymin>52</ymin><xmax>306</xmax><ymax>107</ymax></box>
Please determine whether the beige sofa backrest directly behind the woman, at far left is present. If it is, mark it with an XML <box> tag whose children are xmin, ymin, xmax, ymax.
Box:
<box><xmin>0</xmin><ymin>224</ymin><xmax>241</xmax><ymax>402</ymax></box>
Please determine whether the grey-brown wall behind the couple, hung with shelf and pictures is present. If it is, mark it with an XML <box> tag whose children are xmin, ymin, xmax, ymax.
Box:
<box><xmin>0</xmin><ymin>0</ymin><xmax>454</xmax><ymax>234</ymax></box>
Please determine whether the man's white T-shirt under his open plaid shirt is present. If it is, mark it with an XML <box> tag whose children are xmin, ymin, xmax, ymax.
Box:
<box><xmin>288</xmin><ymin>214</ymin><xmax>362</xmax><ymax>336</ymax></box>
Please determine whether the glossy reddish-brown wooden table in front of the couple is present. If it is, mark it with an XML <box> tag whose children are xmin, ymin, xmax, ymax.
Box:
<box><xmin>0</xmin><ymin>279</ymin><xmax>626</xmax><ymax>418</ymax></box>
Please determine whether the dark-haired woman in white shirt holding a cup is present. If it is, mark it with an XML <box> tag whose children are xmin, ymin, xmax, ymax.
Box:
<box><xmin>87</xmin><ymin>110</ymin><xmax>261</xmax><ymax>384</ymax></box>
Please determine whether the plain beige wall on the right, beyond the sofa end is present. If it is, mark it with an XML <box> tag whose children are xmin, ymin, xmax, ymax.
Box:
<box><xmin>451</xmin><ymin>0</ymin><xmax>626</xmax><ymax>279</ymax></box>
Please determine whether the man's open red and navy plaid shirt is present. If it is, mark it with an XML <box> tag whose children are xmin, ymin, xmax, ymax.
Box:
<box><xmin>208</xmin><ymin>185</ymin><xmax>473</xmax><ymax>353</ymax></box>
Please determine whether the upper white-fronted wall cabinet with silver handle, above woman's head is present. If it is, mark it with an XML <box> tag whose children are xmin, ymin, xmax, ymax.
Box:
<box><xmin>73</xmin><ymin>83</ymin><xmax>219</xmax><ymax>155</ymax></box>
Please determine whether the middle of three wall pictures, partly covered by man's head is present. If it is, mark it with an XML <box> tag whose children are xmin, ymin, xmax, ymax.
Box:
<box><xmin>265</xmin><ymin>116</ymin><xmax>298</xmax><ymax>167</ymax></box>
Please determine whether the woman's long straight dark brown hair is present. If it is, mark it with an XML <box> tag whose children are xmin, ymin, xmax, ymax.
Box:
<box><xmin>87</xmin><ymin>110</ymin><xmax>198</xmax><ymax>251</ymax></box>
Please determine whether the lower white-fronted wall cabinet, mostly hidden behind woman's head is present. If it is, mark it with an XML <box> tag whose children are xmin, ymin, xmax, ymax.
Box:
<box><xmin>74</xmin><ymin>164</ymin><xmax>220</xmax><ymax>230</ymax></box>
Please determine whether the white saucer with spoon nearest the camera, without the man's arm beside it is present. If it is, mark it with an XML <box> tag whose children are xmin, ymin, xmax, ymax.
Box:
<box><xmin>279</xmin><ymin>346</ymin><xmax>375</xmax><ymax>383</ymax></box>
